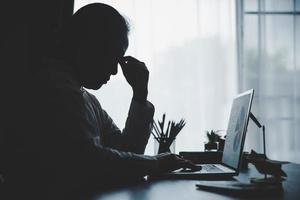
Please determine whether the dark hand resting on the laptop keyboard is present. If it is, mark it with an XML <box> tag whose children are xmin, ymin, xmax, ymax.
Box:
<box><xmin>154</xmin><ymin>153</ymin><xmax>199</xmax><ymax>174</ymax></box>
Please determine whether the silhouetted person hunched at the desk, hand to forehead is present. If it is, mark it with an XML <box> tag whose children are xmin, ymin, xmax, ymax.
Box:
<box><xmin>21</xmin><ymin>3</ymin><xmax>195</xmax><ymax>195</ymax></box>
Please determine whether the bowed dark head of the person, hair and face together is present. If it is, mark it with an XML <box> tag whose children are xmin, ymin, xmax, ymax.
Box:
<box><xmin>59</xmin><ymin>3</ymin><xmax>129</xmax><ymax>89</ymax></box>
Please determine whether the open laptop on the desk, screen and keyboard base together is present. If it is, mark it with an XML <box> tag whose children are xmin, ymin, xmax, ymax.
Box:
<box><xmin>163</xmin><ymin>89</ymin><xmax>254</xmax><ymax>179</ymax></box>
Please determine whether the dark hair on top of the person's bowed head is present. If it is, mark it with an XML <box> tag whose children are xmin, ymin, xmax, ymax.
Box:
<box><xmin>58</xmin><ymin>3</ymin><xmax>129</xmax><ymax>57</ymax></box>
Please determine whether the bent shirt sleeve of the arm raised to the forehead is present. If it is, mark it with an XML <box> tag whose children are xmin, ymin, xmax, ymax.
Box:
<box><xmin>101</xmin><ymin>99</ymin><xmax>154</xmax><ymax>154</ymax></box>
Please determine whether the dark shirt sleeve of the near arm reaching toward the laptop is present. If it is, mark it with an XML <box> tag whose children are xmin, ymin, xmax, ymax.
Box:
<box><xmin>30</xmin><ymin>61</ymin><xmax>157</xmax><ymax>184</ymax></box>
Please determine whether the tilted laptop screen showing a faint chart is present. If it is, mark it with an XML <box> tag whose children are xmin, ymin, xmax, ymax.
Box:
<box><xmin>222</xmin><ymin>90</ymin><xmax>253</xmax><ymax>169</ymax></box>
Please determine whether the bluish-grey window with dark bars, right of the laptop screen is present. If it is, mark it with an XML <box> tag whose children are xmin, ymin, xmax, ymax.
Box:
<box><xmin>237</xmin><ymin>0</ymin><xmax>300</xmax><ymax>162</ymax></box>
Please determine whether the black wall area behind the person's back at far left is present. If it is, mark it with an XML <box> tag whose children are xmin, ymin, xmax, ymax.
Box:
<box><xmin>0</xmin><ymin>0</ymin><xmax>73</xmax><ymax>178</ymax></box>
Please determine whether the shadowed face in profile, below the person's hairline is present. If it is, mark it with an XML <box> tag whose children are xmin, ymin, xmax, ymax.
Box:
<box><xmin>77</xmin><ymin>37</ymin><xmax>128</xmax><ymax>90</ymax></box>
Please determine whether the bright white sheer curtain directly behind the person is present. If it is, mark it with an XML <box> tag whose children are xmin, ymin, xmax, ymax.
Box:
<box><xmin>74</xmin><ymin>0</ymin><xmax>237</xmax><ymax>155</ymax></box>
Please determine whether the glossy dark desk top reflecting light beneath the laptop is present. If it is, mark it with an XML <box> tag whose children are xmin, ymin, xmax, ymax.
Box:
<box><xmin>91</xmin><ymin>164</ymin><xmax>300</xmax><ymax>200</ymax></box>
